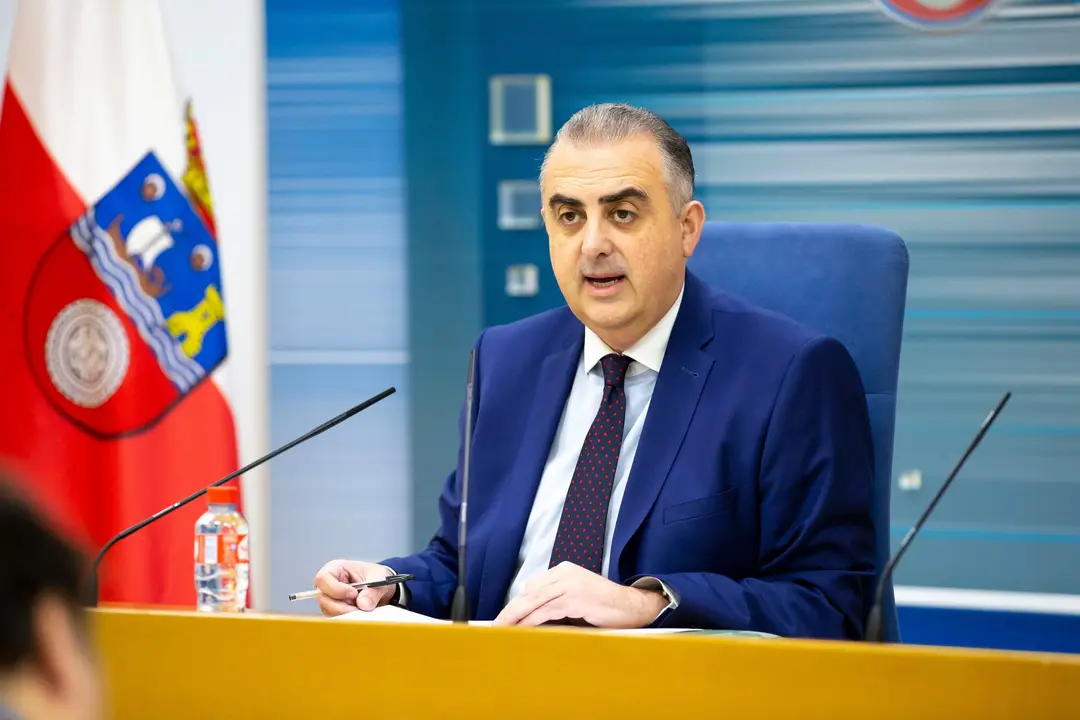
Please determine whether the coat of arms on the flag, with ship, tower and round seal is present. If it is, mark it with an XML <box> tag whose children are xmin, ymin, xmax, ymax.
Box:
<box><xmin>23</xmin><ymin>153</ymin><xmax>227</xmax><ymax>438</ymax></box>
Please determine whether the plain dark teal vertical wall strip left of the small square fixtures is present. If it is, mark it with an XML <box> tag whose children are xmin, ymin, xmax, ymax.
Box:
<box><xmin>401</xmin><ymin>0</ymin><xmax>487</xmax><ymax>548</ymax></box>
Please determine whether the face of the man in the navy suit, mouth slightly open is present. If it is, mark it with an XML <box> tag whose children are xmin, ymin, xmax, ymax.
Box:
<box><xmin>541</xmin><ymin>134</ymin><xmax>704</xmax><ymax>352</ymax></box>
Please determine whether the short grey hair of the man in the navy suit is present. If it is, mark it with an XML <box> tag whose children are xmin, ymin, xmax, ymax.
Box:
<box><xmin>540</xmin><ymin>103</ymin><xmax>693</xmax><ymax>212</ymax></box>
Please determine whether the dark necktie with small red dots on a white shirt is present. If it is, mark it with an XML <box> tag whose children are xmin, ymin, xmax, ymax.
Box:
<box><xmin>549</xmin><ymin>353</ymin><xmax>632</xmax><ymax>574</ymax></box>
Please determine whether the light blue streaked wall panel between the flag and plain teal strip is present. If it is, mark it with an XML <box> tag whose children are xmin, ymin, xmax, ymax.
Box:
<box><xmin>267</xmin><ymin>0</ymin><xmax>411</xmax><ymax>612</ymax></box>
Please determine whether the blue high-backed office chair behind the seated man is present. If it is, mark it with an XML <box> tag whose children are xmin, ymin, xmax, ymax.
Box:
<box><xmin>689</xmin><ymin>222</ymin><xmax>908</xmax><ymax>642</ymax></box>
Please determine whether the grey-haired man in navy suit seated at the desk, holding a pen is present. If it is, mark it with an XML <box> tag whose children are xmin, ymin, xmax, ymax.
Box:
<box><xmin>315</xmin><ymin>105</ymin><xmax>875</xmax><ymax>638</ymax></box>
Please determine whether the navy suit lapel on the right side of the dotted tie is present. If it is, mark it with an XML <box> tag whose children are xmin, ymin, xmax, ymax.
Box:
<box><xmin>608</xmin><ymin>273</ymin><xmax>713</xmax><ymax>582</ymax></box>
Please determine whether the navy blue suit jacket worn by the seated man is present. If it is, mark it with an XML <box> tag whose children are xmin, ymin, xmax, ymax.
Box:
<box><xmin>384</xmin><ymin>273</ymin><xmax>875</xmax><ymax>638</ymax></box>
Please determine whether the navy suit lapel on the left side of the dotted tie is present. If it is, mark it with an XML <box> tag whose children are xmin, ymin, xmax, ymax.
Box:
<box><xmin>477</xmin><ymin>311</ymin><xmax>584</xmax><ymax>617</ymax></box>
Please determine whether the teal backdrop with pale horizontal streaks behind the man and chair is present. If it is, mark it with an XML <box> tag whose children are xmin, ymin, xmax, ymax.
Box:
<box><xmin>474</xmin><ymin>0</ymin><xmax>1080</xmax><ymax>593</ymax></box>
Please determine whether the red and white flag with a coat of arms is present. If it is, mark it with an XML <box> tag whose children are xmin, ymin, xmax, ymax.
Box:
<box><xmin>0</xmin><ymin>0</ymin><xmax>247</xmax><ymax>607</ymax></box>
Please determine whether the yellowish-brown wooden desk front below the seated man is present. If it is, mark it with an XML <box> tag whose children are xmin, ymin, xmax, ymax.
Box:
<box><xmin>93</xmin><ymin>609</ymin><xmax>1080</xmax><ymax>720</ymax></box>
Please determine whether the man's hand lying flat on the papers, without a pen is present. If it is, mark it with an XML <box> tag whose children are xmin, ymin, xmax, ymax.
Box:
<box><xmin>495</xmin><ymin>562</ymin><xmax>667</xmax><ymax>628</ymax></box>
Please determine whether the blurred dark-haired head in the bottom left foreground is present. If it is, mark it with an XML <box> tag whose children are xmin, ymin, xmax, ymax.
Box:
<box><xmin>0</xmin><ymin>475</ymin><xmax>100</xmax><ymax>720</ymax></box>
